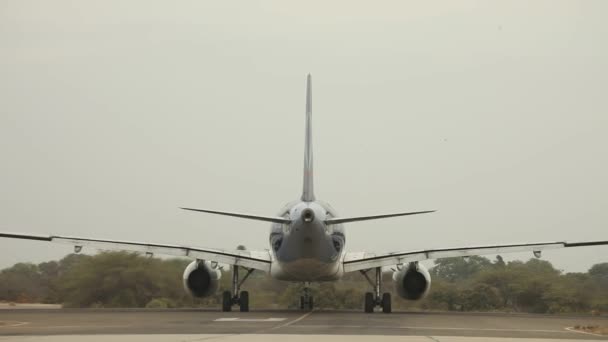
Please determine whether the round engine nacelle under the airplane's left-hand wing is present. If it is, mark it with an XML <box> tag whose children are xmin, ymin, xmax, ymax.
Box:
<box><xmin>183</xmin><ymin>260</ymin><xmax>222</xmax><ymax>298</ymax></box>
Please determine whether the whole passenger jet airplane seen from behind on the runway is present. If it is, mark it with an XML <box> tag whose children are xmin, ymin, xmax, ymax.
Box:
<box><xmin>0</xmin><ymin>74</ymin><xmax>608</xmax><ymax>313</ymax></box>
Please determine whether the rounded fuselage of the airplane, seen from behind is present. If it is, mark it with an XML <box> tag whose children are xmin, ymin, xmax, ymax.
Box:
<box><xmin>270</xmin><ymin>201</ymin><xmax>346</xmax><ymax>281</ymax></box>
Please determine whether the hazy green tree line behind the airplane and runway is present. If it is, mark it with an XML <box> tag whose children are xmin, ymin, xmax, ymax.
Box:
<box><xmin>0</xmin><ymin>252</ymin><xmax>608</xmax><ymax>313</ymax></box>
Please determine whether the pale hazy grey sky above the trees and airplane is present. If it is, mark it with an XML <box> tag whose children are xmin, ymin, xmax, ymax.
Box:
<box><xmin>0</xmin><ymin>0</ymin><xmax>608</xmax><ymax>271</ymax></box>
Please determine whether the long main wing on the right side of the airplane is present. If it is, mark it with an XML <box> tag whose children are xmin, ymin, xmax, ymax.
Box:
<box><xmin>344</xmin><ymin>241</ymin><xmax>608</xmax><ymax>272</ymax></box>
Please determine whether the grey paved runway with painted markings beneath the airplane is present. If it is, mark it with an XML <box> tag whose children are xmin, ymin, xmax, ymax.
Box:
<box><xmin>0</xmin><ymin>309</ymin><xmax>608</xmax><ymax>342</ymax></box>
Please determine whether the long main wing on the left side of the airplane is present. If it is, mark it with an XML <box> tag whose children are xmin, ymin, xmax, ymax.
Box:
<box><xmin>0</xmin><ymin>232</ymin><xmax>270</xmax><ymax>272</ymax></box>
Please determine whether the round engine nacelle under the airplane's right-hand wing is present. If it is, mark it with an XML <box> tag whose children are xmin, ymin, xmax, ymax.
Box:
<box><xmin>393</xmin><ymin>262</ymin><xmax>431</xmax><ymax>300</ymax></box>
